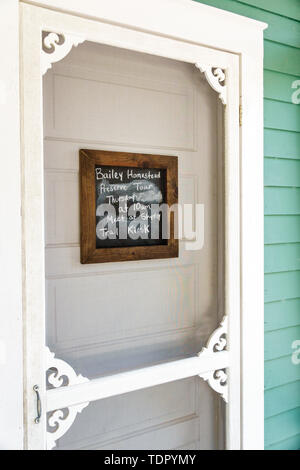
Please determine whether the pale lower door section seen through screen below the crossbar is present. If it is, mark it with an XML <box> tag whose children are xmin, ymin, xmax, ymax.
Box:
<box><xmin>58</xmin><ymin>378</ymin><xmax>215</xmax><ymax>450</ymax></box>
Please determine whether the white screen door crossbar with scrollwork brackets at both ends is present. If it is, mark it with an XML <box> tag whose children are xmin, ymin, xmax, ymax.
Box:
<box><xmin>45</xmin><ymin>316</ymin><xmax>230</xmax><ymax>450</ymax></box>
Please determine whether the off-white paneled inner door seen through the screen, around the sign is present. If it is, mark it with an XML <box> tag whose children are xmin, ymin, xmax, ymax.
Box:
<box><xmin>43</xmin><ymin>42</ymin><xmax>224</xmax><ymax>449</ymax></box>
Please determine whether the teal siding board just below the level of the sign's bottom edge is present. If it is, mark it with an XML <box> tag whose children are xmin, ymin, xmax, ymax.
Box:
<box><xmin>265</xmin><ymin>271</ymin><xmax>300</xmax><ymax>302</ymax></box>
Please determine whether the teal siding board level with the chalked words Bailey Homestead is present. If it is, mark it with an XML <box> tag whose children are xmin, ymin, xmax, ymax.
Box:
<box><xmin>264</xmin><ymin>158</ymin><xmax>300</xmax><ymax>188</ymax></box>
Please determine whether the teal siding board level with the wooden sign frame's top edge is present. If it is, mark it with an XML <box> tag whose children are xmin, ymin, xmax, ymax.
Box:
<box><xmin>264</xmin><ymin>129</ymin><xmax>300</xmax><ymax>159</ymax></box>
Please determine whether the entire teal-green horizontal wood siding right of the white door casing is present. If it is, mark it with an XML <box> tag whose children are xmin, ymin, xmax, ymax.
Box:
<box><xmin>196</xmin><ymin>0</ymin><xmax>300</xmax><ymax>450</ymax></box>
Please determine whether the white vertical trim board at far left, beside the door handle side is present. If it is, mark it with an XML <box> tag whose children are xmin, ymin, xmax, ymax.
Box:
<box><xmin>0</xmin><ymin>0</ymin><xmax>24</xmax><ymax>450</ymax></box>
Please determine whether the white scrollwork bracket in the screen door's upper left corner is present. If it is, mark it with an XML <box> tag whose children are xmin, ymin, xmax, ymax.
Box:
<box><xmin>41</xmin><ymin>31</ymin><xmax>85</xmax><ymax>75</ymax></box>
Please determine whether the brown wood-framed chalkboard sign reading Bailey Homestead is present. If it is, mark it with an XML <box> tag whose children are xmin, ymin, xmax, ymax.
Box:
<box><xmin>79</xmin><ymin>150</ymin><xmax>178</xmax><ymax>263</ymax></box>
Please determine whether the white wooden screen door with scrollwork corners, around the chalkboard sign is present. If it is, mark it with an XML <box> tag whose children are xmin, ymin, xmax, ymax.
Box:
<box><xmin>23</xmin><ymin>5</ymin><xmax>240</xmax><ymax>449</ymax></box>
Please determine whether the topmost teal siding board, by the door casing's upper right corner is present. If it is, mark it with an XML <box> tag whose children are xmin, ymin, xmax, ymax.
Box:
<box><xmin>195</xmin><ymin>0</ymin><xmax>300</xmax><ymax>47</ymax></box>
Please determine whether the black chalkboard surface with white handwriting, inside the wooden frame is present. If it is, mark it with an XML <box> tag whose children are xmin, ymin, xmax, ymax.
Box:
<box><xmin>95</xmin><ymin>165</ymin><xmax>168</xmax><ymax>248</ymax></box>
